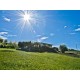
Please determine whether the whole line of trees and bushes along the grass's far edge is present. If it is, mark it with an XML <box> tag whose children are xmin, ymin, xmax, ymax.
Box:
<box><xmin>0</xmin><ymin>38</ymin><xmax>70</xmax><ymax>53</ymax></box>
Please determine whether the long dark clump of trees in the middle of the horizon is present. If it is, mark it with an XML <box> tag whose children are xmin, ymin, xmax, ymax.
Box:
<box><xmin>18</xmin><ymin>41</ymin><xmax>58</xmax><ymax>52</ymax></box>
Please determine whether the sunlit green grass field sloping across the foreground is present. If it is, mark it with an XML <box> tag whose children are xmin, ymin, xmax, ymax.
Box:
<box><xmin>0</xmin><ymin>48</ymin><xmax>80</xmax><ymax>70</ymax></box>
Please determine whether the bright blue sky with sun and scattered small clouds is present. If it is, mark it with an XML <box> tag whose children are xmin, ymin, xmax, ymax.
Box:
<box><xmin>0</xmin><ymin>10</ymin><xmax>80</xmax><ymax>49</ymax></box>
